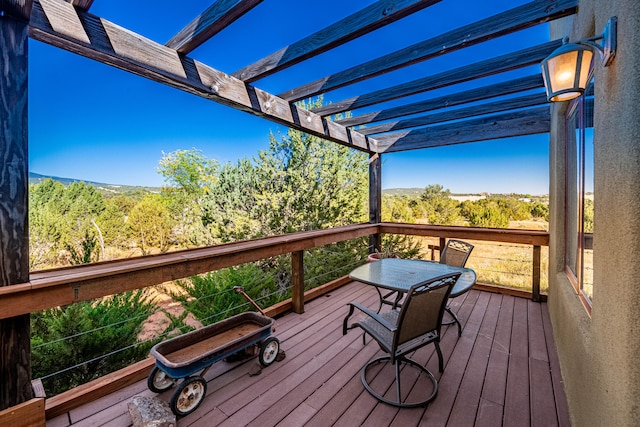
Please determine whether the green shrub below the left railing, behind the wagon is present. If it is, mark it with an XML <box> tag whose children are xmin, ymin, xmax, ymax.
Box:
<box><xmin>31</xmin><ymin>290</ymin><xmax>155</xmax><ymax>395</ymax></box>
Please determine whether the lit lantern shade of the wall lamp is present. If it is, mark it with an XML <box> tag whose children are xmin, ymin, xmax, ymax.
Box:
<box><xmin>540</xmin><ymin>43</ymin><xmax>593</xmax><ymax>101</ymax></box>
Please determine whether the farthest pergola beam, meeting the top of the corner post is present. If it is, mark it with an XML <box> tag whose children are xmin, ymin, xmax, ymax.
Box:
<box><xmin>378</xmin><ymin>107</ymin><xmax>551</xmax><ymax>153</ymax></box>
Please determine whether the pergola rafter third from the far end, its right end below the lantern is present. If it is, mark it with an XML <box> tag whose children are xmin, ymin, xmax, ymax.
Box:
<box><xmin>338</xmin><ymin>74</ymin><xmax>544</xmax><ymax>126</ymax></box>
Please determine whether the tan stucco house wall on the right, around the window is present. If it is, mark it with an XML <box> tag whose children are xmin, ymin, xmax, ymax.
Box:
<box><xmin>549</xmin><ymin>0</ymin><xmax>640</xmax><ymax>426</ymax></box>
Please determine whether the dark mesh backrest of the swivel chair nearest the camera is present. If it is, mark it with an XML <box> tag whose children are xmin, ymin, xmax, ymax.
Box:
<box><xmin>393</xmin><ymin>272</ymin><xmax>461</xmax><ymax>348</ymax></box>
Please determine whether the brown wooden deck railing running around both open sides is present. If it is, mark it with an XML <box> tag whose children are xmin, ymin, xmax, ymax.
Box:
<box><xmin>0</xmin><ymin>223</ymin><xmax>549</xmax><ymax>418</ymax></box>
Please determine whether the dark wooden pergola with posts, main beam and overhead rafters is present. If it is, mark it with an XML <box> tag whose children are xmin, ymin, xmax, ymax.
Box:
<box><xmin>0</xmin><ymin>0</ymin><xmax>578</xmax><ymax>409</ymax></box>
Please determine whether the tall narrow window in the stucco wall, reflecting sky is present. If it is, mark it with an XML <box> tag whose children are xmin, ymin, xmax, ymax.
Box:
<box><xmin>565</xmin><ymin>80</ymin><xmax>595</xmax><ymax>310</ymax></box>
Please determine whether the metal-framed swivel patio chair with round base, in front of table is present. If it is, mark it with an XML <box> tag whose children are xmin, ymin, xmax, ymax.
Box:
<box><xmin>342</xmin><ymin>273</ymin><xmax>460</xmax><ymax>408</ymax></box>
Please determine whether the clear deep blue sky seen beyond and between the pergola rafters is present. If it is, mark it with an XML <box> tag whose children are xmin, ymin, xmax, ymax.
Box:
<box><xmin>29</xmin><ymin>0</ymin><xmax>549</xmax><ymax>194</ymax></box>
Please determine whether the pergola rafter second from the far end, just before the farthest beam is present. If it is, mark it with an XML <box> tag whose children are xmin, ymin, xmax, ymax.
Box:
<box><xmin>358</xmin><ymin>93</ymin><xmax>548</xmax><ymax>135</ymax></box>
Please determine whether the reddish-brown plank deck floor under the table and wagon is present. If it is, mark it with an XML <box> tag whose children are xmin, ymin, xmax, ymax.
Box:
<box><xmin>47</xmin><ymin>283</ymin><xmax>570</xmax><ymax>427</ymax></box>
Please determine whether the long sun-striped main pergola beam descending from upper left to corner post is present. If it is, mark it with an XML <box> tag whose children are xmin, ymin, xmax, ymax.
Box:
<box><xmin>30</xmin><ymin>0</ymin><xmax>370</xmax><ymax>151</ymax></box>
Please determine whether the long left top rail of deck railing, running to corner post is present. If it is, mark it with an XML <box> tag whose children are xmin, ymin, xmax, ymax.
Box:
<box><xmin>0</xmin><ymin>224</ymin><xmax>377</xmax><ymax>318</ymax></box>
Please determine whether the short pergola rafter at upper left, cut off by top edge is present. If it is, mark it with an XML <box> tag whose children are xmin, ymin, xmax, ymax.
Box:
<box><xmin>166</xmin><ymin>0</ymin><xmax>262</xmax><ymax>55</ymax></box>
